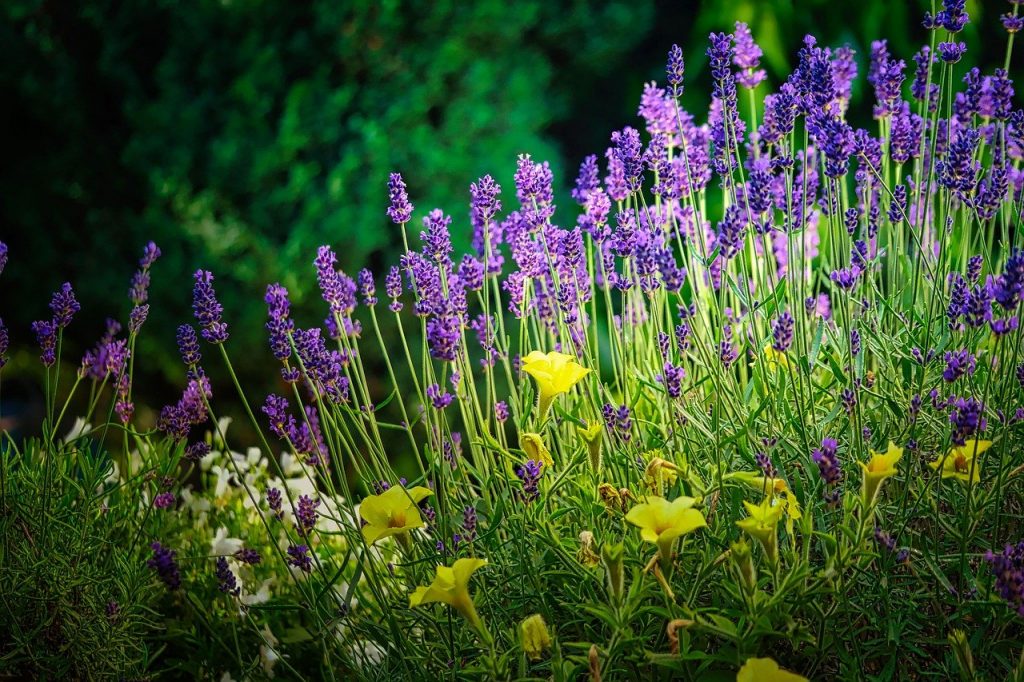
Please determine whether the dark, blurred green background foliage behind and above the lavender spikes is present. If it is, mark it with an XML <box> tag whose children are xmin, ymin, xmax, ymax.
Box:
<box><xmin>0</xmin><ymin>0</ymin><xmax>1009</xmax><ymax>432</ymax></box>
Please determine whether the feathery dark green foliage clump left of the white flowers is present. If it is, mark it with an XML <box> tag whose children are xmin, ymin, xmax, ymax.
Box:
<box><xmin>0</xmin><ymin>441</ymin><xmax>159</xmax><ymax>679</ymax></box>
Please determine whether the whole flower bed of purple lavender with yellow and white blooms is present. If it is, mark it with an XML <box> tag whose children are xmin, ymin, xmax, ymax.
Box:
<box><xmin>0</xmin><ymin>0</ymin><xmax>1024</xmax><ymax>682</ymax></box>
